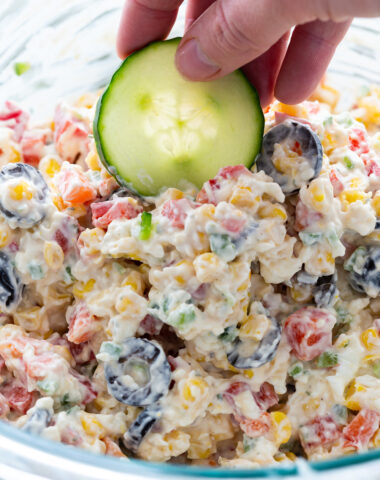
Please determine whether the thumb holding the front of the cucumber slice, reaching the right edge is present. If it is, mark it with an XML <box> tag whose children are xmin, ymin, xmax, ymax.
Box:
<box><xmin>176</xmin><ymin>0</ymin><xmax>380</xmax><ymax>80</ymax></box>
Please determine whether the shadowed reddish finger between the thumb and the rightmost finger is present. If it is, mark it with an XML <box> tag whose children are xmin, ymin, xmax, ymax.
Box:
<box><xmin>243</xmin><ymin>32</ymin><xmax>290</xmax><ymax>108</ymax></box>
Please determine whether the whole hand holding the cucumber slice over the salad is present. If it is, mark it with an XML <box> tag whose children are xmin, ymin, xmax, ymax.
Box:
<box><xmin>118</xmin><ymin>0</ymin><xmax>380</xmax><ymax>106</ymax></box>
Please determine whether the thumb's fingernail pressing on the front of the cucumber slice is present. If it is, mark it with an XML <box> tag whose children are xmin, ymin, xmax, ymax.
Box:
<box><xmin>176</xmin><ymin>38</ymin><xmax>220</xmax><ymax>80</ymax></box>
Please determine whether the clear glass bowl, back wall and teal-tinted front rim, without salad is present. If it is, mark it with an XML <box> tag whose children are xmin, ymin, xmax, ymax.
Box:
<box><xmin>0</xmin><ymin>0</ymin><xmax>380</xmax><ymax>480</ymax></box>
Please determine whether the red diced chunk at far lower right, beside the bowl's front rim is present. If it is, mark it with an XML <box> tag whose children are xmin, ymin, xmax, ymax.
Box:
<box><xmin>343</xmin><ymin>409</ymin><xmax>380</xmax><ymax>450</ymax></box>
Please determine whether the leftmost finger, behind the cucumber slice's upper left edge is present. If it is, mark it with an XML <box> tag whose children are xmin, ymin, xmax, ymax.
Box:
<box><xmin>117</xmin><ymin>0</ymin><xmax>183</xmax><ymax>58</ymax></box>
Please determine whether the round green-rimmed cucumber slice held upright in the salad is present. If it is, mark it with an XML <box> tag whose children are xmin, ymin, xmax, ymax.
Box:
<box><xmin>94</xmin><ymin>38</ymin><xmax>264</xmax><ymax>195</ymax></box>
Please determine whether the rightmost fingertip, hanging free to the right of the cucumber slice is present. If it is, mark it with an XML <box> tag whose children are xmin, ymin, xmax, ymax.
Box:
<box><xmin>275</xmin><ymin>20</ymin><xmax>351</xmax><ymax>104</ymax></box>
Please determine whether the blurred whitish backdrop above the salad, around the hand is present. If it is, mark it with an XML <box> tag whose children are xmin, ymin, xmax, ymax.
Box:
<box><xmin>0</xmin><ymin>0</ymin><xmax>380</xmax><ymax>121</ymax></box>
